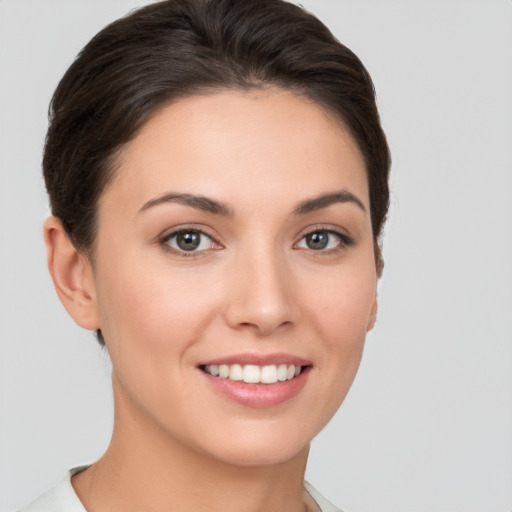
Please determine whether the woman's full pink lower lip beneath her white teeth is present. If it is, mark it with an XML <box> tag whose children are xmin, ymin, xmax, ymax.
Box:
<box><xmin>199</xmin><ymin>366</ymin><xmax>311</xmax><ymax>409</ymax></box>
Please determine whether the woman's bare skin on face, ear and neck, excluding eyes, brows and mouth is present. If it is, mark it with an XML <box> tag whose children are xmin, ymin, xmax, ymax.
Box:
<box><xmin>45</xmin><ymin>90</ymin><xmax>377</xmax><ymax>512</ymax></box>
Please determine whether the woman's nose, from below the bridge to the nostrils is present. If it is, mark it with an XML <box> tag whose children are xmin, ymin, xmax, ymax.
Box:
<box><xmin>225</xmin><ymin>250</ymin><xmax>296</xmax><ymax>336</ymax></box>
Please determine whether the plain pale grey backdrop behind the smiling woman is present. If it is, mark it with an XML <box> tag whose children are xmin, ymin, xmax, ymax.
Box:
<box><xmin>0</xmin><ymin>0</ymin><xmax>512</xmax><ymax>512</ymax></box>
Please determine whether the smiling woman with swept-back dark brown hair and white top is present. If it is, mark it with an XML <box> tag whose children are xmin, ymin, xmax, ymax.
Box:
<box><xmin>19</xmin><ymin>0</ymin><xmax>389</xmax><ymax>512</ymax></box>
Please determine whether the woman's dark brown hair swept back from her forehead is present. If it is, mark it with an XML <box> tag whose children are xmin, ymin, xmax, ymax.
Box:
<box><xmin>43</xmin><ymin>0</ymin><xmax>390</xmax><ymax>343</ymax></box>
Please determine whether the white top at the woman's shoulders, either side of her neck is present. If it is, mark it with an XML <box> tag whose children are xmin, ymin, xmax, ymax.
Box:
<box><xmin>19</xmin><ymin>467</ymin><xmax>343</xmax><ymax>512</ymax></box>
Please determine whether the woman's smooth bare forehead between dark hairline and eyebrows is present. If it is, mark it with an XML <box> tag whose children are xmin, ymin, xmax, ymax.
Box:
<box><xmin>100</xmin><ymin>90</ymin><xmax>368</xmax><ymax>213</ymax></box>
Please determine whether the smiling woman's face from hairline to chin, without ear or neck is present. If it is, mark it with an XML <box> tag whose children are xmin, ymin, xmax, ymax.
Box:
<box><xmin>88</xmin><ymin>91</ymin><xmax>376</xmax><ymax>465</ymax></box>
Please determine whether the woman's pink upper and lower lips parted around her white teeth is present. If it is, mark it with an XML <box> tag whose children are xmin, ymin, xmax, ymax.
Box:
<box><xmin>197</xmin><ymin>354</ymin><xmax>312</xmax><ymax>409</ymax></box>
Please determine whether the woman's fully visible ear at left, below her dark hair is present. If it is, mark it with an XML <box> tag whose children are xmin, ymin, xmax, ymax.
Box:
<box><xmin>44</xmin><ymin>217</ymin><xmax>100</xmax><ymax>330</ymax></box>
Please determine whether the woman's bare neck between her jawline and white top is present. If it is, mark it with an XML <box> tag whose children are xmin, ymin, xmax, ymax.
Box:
<box><xmin>72</xmin><ymin>374</ymin><xmax>309</xmax><ymax>512</ymax></box>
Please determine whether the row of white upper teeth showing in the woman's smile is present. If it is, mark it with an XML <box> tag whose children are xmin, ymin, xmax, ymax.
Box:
<box><xmin>201</xmin><ymin>364</ymin><xmax>303</xmax><ymax>384</ymax></box>
